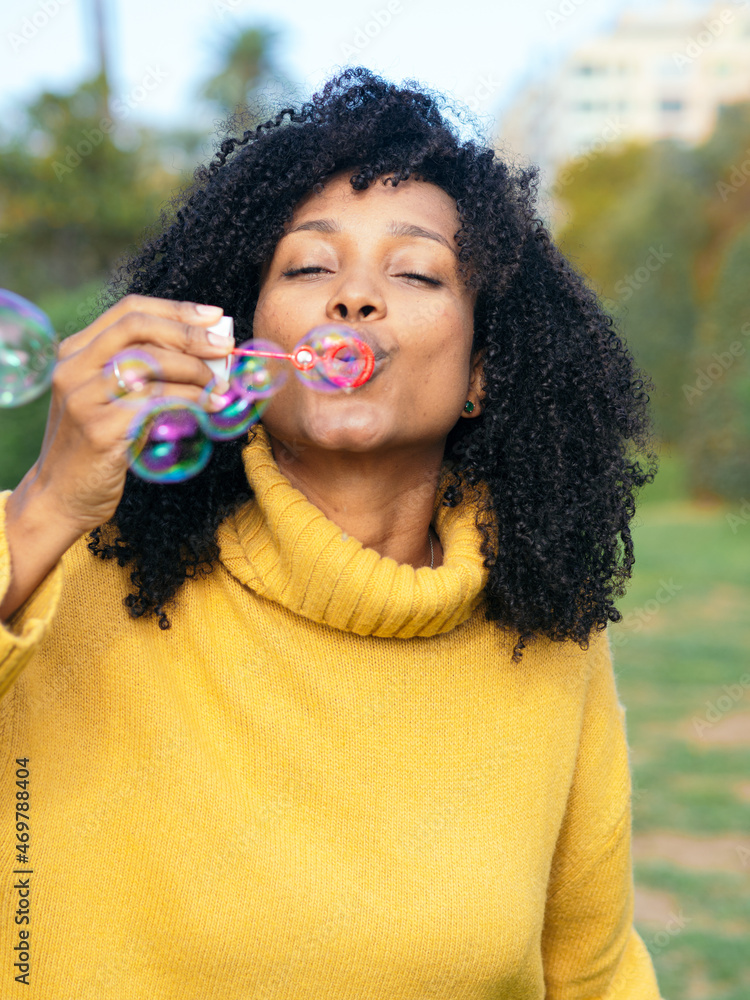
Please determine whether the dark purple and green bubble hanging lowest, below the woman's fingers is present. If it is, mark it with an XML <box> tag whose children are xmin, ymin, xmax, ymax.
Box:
<box><xmin>129</xmin><ymin>396</ymin><xmax>214</xmax><ymax>483</ymax></box>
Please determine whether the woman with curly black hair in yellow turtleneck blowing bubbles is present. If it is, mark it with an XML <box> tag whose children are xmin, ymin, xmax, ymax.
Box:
<box><xmin>0</xmin><ymin>69</ymin><xmax>659</xmax><ymax>1000</ymax></box>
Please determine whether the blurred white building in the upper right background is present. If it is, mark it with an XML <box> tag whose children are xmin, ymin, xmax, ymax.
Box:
<box><xmin>498</xmin><ymin>0</ymin><xmax>750</xmax><ymax>185</ymax></box>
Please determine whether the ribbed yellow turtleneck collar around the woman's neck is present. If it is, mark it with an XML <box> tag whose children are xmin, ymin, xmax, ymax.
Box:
<box><xmin>214</xmin><ymin>425</ymin><xmax>487</xmax><ymax>639</ymax></box>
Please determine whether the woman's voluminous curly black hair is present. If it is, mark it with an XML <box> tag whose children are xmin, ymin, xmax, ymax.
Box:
<box><xmin>89</xmin><ymin>67</ymin><xmax>657</xmax><ymax>661</ymax></box>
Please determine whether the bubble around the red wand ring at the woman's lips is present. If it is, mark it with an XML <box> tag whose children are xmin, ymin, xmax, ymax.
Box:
<box><xmin>292</xmin><ymin>323</ymin><xmax>376</xmax><ymax>392</ymax></box>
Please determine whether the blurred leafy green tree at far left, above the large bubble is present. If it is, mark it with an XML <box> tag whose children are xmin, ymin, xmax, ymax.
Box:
<box><xmin>0</xmin><ymin>79</ymin><xmax>181</xmax><ymax>300</ymax></box>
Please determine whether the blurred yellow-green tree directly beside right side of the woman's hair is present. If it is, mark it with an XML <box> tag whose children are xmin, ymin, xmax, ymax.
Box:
<box><xmin>558</xmin><ymin>143</ymin><xmax>706</xmax><ymax>442</ymax></box>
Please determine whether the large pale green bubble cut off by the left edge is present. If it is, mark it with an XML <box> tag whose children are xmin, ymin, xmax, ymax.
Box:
<box><xmin>0</xmin><ymin>288</ymin><xmax>57</xmax><ymax>407</ymax></box>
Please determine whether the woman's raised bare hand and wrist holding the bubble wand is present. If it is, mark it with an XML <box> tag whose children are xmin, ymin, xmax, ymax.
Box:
<box><xmin>0</xmin><ymin>295</ymin><xmax>233</xmax><ymax>619</ymax></box>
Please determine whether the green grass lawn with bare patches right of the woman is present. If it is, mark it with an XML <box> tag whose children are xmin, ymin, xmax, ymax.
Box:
<box><xmin>610</xmin><ymin>448</ymin><xmax>750</xmax><ymax>1000</ymax></box>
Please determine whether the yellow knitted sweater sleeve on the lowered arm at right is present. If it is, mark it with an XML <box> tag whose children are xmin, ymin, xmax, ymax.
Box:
<box><xmin>542</xmin><ymin>632</ymin><xmax>660</xmax><ymax>1000</ymax></box>
